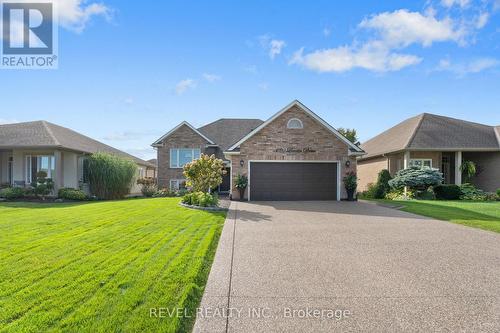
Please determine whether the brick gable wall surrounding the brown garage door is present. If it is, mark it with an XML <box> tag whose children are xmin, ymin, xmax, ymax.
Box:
<box><xmin>231</xmin><ymin>105</ymin><xmax>356</xmax><ymax>199</ymax></box>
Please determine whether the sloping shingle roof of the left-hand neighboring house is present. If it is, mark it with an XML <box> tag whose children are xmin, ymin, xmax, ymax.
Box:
<box><xmin>0</xmin><ymin>120</ymin><xmax>155</xmax><ymax>167</ymax></box>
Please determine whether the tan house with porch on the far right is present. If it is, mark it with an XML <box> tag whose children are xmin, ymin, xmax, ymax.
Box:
<box><xmin>358</xmin><ymin>113</ymin><xmax>500</xmax><ymax>191</ymax></box>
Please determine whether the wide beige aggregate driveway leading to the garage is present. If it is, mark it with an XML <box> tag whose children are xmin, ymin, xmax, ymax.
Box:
<box><xmin>194</xmin><ymin>202</ymin><xmax>500</xmax><ymax>332</ymax></box>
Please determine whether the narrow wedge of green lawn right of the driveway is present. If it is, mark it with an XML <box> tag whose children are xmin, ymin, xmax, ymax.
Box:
<box><xmin>376</xmin><ymin>200</ymin><xmax>500</xmax><ymax>232</ymax></box>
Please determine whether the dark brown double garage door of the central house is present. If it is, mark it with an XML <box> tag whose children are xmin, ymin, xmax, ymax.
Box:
<box><xmin>250</xmin><ymin>162</ymin><xmax>337</xmax><ymax>201</ymax></box>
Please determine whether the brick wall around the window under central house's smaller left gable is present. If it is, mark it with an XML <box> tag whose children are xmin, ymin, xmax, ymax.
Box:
<box><xmin>157</xmin><ymin>125</ymin><xmax>209</xmax><ymax>188</ymax></box>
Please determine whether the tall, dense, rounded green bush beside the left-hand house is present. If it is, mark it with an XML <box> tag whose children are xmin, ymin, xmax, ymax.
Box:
<box><xmin>86</xmin><ymin>153</ymin><xmax>137</xmax><ymax>199</ymax></box>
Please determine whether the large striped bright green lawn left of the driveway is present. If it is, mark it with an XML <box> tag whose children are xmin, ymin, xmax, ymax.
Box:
<box><xmin>0</xmin><ymin>198</ymin><xmax>225</xmax><ymax>332</ymax></box>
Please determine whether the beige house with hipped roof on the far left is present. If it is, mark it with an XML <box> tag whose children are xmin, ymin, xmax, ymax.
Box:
<box><xmin>0</xmin><ymin>121</ymin><xmax>156</xmax><ymax>193</ymax></box>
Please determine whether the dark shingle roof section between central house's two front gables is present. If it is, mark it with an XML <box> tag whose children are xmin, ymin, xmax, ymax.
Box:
<box><xmin>198</xmin><ymin>118</ymin><xmax>263</xmax><ymax>151</ymax></box>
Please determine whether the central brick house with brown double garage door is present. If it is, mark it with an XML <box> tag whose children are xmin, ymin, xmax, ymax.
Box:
<box><xmin>153</xmin><ymin>101</ymin><xmax>364</xmax><ymax>200</ymax></box>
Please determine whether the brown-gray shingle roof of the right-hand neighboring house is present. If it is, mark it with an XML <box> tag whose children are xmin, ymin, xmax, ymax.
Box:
<box><xmin>361</xmin><ymin>113</ymin><xmax>500</xmax><ymax>158</ymax></box>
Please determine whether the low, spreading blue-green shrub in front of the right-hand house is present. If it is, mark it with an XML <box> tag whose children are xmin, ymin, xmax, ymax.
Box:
<box><xmin>389</xmin><ymin>167</ymin><xmax>443</xmax><ymax>191</ymax></box>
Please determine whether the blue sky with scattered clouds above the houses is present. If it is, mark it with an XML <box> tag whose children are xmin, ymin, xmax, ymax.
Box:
<box><xmin>0</xmin><ymin>0</ymin><xmax>500</xmax><ymax>158</ymax></box>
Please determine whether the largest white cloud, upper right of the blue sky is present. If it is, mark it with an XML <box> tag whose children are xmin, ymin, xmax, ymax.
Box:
<box><xmin>289</xmin><ymin>9</ymin><xmax>467</xmax><ymax>72</ymax></box>
